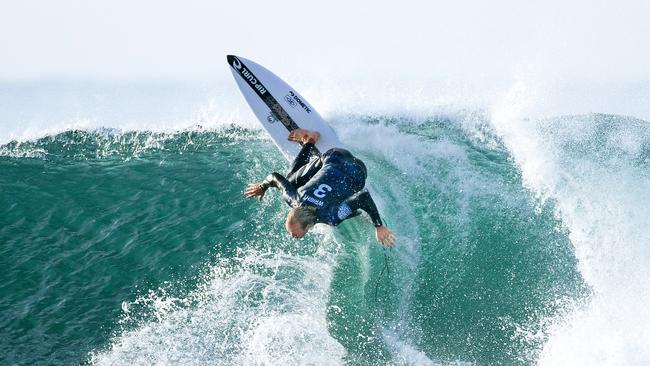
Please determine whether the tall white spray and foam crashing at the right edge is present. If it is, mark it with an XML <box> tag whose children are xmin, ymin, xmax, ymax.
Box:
<box><xmin>492</xmin><ymin>79</ymin><xmax>650</xmax><ymax>365</ymax></box>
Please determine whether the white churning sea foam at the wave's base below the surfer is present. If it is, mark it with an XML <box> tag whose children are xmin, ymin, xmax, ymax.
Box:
<box><xmin>91</xmin><ymin>242</ymin><xmax>344</xmax><ymax>365</ymax></box>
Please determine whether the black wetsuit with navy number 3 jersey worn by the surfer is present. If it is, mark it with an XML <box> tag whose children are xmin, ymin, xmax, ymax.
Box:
<box><xmin>262</xmin><ymin>143</ymin><xmax>382</xmax><ymax>226</ymax></box>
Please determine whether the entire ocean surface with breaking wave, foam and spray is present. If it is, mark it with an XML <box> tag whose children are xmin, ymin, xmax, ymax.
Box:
<box><xmin>0</xmin><ymin>78</ymin><xmax>650</xmax><ymax>365</ymax></box>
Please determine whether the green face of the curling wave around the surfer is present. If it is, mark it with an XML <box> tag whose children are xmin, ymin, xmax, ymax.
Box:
<box><xmin>0</xmin><ymin>118</ymin><xmax>588</xmax><ymax>365</ymax></box>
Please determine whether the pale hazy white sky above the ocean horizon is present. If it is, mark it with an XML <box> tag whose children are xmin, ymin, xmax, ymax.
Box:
<box><xmin>0</xmin><ymin>0</ymin><xmax>650</xmax><ymax>80</ymax></box>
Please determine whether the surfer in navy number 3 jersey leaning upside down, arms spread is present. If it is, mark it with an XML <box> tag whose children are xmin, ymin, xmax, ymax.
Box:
<box><xmin>244</xmin><ymin>129</ymin><xmax>395</xmax><ymax>246</ymax></box>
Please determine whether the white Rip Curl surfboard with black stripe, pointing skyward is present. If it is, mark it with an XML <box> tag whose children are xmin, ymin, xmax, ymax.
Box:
<box><xmin>227</xmin><ymin>55</ymin><xmax>343</xmax><ymax>160</ymax></box>
